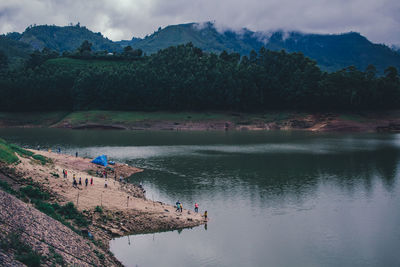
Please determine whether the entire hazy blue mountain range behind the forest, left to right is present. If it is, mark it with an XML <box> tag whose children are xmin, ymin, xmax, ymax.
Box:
<box><xmin>0</xmin><ymin>22</ymin><xmax>400</xmax><ymax>73</ymax></box>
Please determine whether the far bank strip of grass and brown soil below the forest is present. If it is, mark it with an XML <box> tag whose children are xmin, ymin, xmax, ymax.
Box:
<box><xmin>0</xmin><ymin>110</ymin><xmax>400</xmax><ymax>132</ymax></box>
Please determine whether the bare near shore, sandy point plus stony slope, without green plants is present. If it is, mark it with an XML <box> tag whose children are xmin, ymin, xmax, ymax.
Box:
<box><xmin>0</xmin><ymin>150</ymin><xmax>204</xmax><ymax>266</ymax></box>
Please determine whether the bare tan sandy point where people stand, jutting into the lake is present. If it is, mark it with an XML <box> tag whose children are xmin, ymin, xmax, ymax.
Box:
<box><xmin>0</xmin><ymin>150</ymin><xmax>205</xmax><ymax>266</ymax></box>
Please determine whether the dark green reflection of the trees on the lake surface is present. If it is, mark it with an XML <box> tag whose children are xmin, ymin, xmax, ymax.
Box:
<box><xmin>130</xmin><ymin>148</ymin><xmax>400</xmax><ymax>201</ymax></box>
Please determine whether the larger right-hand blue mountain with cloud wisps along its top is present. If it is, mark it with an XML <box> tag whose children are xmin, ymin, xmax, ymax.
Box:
<box><xmin>124</xmin><ymin>22</ymin><xmax>400</xmax><ymax>72</ymax></box>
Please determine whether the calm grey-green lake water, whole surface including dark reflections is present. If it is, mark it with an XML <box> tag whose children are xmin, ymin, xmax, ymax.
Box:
<box><xmin>0</xmin><ymin>129</ymin><xmax>400</xmax><ymax>266</ymax></box>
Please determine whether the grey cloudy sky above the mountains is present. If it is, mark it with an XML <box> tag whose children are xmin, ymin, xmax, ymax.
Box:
<box><xmin>0</xmin><ymin>0</ymin><xmax>400</xmax><ymax>44</ymax></box>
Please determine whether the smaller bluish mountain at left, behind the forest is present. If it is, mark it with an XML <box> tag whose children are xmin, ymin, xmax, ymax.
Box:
<box><xmin>10</xmin><ymin>24</ymin><xmax>121</xmax><ymax>52</ymax></box>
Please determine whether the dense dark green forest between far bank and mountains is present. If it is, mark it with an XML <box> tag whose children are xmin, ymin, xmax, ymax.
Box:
<box><xmin>0</xmin><ymin>41</ymin><xmax>400</xmax><ymax>112</ymax></box>
